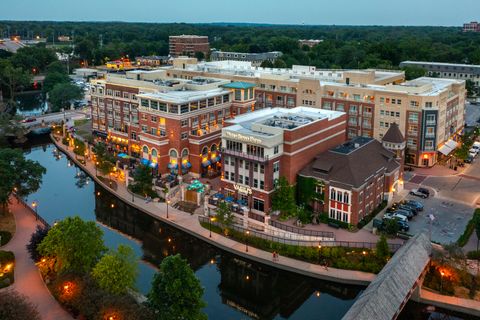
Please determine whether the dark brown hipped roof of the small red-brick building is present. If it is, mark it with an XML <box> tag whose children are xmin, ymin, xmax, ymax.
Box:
<box><xmin>300</xmin><ymin>137</ymin><xmax>400</xmax><ymax>188</ymax></box>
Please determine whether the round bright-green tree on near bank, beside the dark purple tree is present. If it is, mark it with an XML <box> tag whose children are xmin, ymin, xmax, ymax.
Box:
<box><xmin>38</xmin><ymin>216</ymin><xmax>105</xmax><ymax>272</ymax></box>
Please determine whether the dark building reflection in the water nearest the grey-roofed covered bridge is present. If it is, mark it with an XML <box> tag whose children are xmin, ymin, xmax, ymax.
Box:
<box><xmin>219</xmin><ymin>254</ymin><xmax>361</xmax><ymax>319</ymax></box>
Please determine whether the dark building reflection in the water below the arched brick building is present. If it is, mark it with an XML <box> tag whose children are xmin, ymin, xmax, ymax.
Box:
<box><xmin>95</xmin><ymin>185</ymin><xmax>216</xmax><ymax>270</ymax></box>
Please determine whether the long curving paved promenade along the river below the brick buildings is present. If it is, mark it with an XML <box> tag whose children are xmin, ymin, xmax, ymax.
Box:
<box><xmin>50</xmin><ymin>135</ymin><xmax>376</xmax><ymax>286</ymax></box>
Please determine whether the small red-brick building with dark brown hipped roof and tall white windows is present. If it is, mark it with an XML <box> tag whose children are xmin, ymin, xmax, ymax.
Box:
<box><xmin>297</xmin><ymin>134</ymin><xmax>403</xmax><ymax>224</ymax></box>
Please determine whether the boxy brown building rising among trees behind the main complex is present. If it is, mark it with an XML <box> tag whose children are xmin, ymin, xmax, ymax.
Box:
<box><xmin>169</xmin><ymin>35</ymin><xmax>210</xmax><ymax>57</ymax></box>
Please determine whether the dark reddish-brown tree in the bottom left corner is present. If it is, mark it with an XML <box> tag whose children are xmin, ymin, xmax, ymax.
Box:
<box><xmin>0</xmin><ymin>290</ymin><xmax>41</xmax><ymax>320</ymax></box>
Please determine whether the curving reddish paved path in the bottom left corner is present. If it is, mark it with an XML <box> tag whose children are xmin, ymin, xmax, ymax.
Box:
<box><xmin>1</xmin><ymin>199</ymin><xmax>73</xmax><ymax>320</ymax></box>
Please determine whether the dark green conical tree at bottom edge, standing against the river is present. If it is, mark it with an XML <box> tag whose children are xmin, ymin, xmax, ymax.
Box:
<box><xmin>147</xmin><ymin>254</ymin><xmax>207</xmax><ymax>320</ymax></box>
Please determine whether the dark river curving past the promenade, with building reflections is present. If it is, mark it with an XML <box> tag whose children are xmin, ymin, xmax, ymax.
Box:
<box><xmin>20</xmin><ymin>136</ymin><xmax>470</xmax><ymax>320</ymax></box>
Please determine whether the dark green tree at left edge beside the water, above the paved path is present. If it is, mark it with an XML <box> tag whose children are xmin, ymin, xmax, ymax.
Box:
<box><xmin>0</xmin><ymin>148</ymin><xmax>47</xmax><ymax>211</ymax></box>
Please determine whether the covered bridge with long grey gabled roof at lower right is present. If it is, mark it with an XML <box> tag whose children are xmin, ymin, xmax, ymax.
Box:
<box><xmin>342</xmin><ymin>233</ymin><xmax>432</xmax><ymax>320</ymax></box>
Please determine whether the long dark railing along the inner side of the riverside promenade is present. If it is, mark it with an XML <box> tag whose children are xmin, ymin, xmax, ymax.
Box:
<box><xmin>198</xmin><ymin>216</ymin><xmax>402</xmax><ymax>252</ymax></box>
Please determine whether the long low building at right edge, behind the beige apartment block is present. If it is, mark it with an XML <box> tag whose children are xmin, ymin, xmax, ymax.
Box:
<box><xmin>400</xmin><ymin>61</ymin><xmax>480</xmax><ymax>87</ymax></box>
